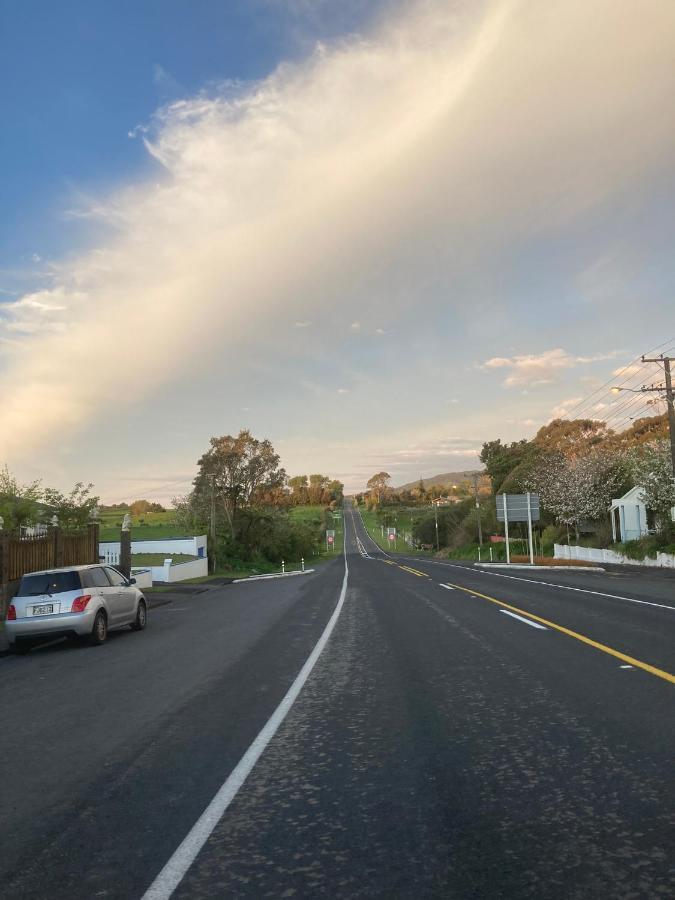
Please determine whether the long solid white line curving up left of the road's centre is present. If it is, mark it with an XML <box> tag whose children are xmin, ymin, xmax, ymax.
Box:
<box><xmin>142</xmin><ymin>516</ymin><xmax>349</xmax><ymax>900</ymax></box>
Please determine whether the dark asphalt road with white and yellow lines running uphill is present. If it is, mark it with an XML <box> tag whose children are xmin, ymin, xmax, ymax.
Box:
<box><xmin>0</xmin><ymin>509</ymin><xmax>675</xmax><ymax>900</ymax></box>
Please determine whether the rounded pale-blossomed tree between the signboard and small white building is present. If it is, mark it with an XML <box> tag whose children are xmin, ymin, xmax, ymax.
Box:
<box><xmin>528</xmin><ymin>451</ymin><xmax>625</xmax><ymax>537</ymax></box>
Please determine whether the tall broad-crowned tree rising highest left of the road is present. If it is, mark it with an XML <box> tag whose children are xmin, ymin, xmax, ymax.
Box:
<box><xmin>194</xmin><ymin>429</ymin><xmax>286</xmax><ymax>540</ymax></box>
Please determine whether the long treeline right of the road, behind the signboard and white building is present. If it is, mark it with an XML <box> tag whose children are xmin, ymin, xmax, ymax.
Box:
<box><xmin>357</xmin><ymin>416</ymin><xmax>675</xmax><ymax>551</ymax></box>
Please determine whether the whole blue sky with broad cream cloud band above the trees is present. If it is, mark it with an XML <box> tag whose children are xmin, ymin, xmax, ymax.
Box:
<box><xmin>0</xmin><ymin>0</ymin><xmax>675</xmax><ymax>502</ymax></box>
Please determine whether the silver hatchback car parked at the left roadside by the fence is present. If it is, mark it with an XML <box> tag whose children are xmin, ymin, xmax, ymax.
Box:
<box><xmin>5</xmin><ymin>566</ymin><xmax>148</xmax><ymax>653</ymax></box>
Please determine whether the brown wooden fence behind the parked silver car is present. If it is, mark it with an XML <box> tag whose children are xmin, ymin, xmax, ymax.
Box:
<box><xmin>0</xmin><ymin>525</ymin><xmax>98</xmax><ymax>615</ymax></box>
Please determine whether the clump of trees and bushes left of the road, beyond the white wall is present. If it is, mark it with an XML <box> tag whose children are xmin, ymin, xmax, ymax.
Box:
<box><xmin>173</xmin><ymin>430</ymin><xmax>343</xmax><ymax>569</ymax></box>
